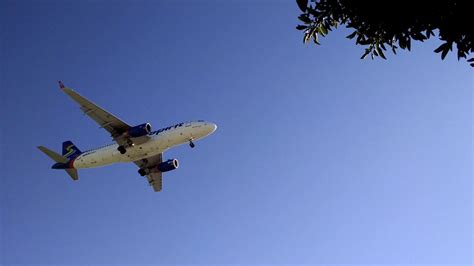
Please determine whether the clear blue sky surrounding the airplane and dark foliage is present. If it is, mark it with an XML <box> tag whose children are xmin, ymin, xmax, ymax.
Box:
<box><xmin>0</xmin><ymin>0</ymin><xmax>474</xmax><ymax>265</ymax></box>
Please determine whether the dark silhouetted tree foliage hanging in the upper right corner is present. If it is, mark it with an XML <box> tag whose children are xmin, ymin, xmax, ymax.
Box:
<box><xmin>296</xmin><ymin>0</ymin><xmax>474</xmax><ymax>67</ymax></box>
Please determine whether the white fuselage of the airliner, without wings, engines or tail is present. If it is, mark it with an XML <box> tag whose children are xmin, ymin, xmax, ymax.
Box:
<box><xmin>73</xmin><ymin>121</ymin><xmax>217</xmax><ymax>169</ymax></box>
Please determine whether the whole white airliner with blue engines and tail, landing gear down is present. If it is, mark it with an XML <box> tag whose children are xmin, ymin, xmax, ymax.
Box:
<box><xmin>38</xmin><ymin>81</ymin><xmax>217</xmax><ymax>192</ymax></box>
